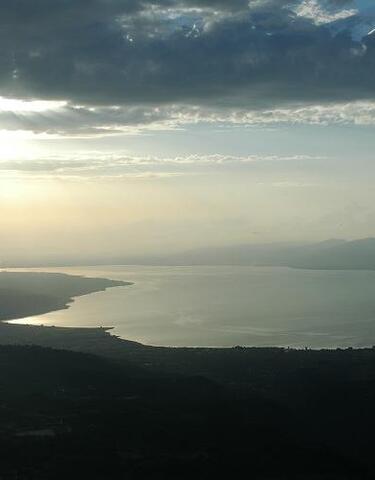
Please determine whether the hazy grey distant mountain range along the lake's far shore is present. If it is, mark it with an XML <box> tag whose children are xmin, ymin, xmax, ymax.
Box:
<box><xmin>2</xmin><ymin>238</ymin><xmax>375</xmax><ymax>270</ymax></box>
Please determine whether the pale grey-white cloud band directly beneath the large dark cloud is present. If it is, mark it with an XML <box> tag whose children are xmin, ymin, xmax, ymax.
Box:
<box><xmin>0</xmin><ymin>101</ymin><xmax>375</xmax><ymax>139</ymax></box>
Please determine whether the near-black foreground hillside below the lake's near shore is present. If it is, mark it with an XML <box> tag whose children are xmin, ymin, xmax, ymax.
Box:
<box><xmin>0</xmin><ymin>346</ymin><xmax>375</xmax><ymax>480</ymax></box>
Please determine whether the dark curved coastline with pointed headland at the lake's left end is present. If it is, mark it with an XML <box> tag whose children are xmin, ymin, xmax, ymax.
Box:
<box><xmin>0</xmin><ymin>271</ymin><xmax>145</xmax><ymax>353</ymax></box>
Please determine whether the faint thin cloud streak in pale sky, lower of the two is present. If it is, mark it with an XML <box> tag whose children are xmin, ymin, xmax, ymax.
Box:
<box><xmin>0</xmin><ymin>152</ymin><xmax>324</xmax><ymax>180</ymax></box>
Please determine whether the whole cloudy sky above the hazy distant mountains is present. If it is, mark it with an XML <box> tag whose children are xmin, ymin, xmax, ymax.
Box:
<box><xmin>0</xmin><ymin>0</ymin><xmax>375</xmax><ymax>261</ymax></box>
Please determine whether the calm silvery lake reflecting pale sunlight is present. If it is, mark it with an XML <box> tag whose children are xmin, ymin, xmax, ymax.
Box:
<box><xmin>8</xmin><ymin>266</ymin><xmax>375</xmax><ymax>348</ymax></box>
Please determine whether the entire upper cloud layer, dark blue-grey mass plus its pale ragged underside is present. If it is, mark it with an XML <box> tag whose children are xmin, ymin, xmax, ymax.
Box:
<box><xmin>0</xmin><ymin>0</ymin><xmax>375</xmax><ymax>135</ymax></box>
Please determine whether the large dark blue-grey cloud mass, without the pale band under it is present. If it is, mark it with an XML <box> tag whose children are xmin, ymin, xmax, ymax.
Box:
<box><xmin>0</xmin><ymin>0</ymin><xmax>375</xmax><ymax>108</ymax></box>
